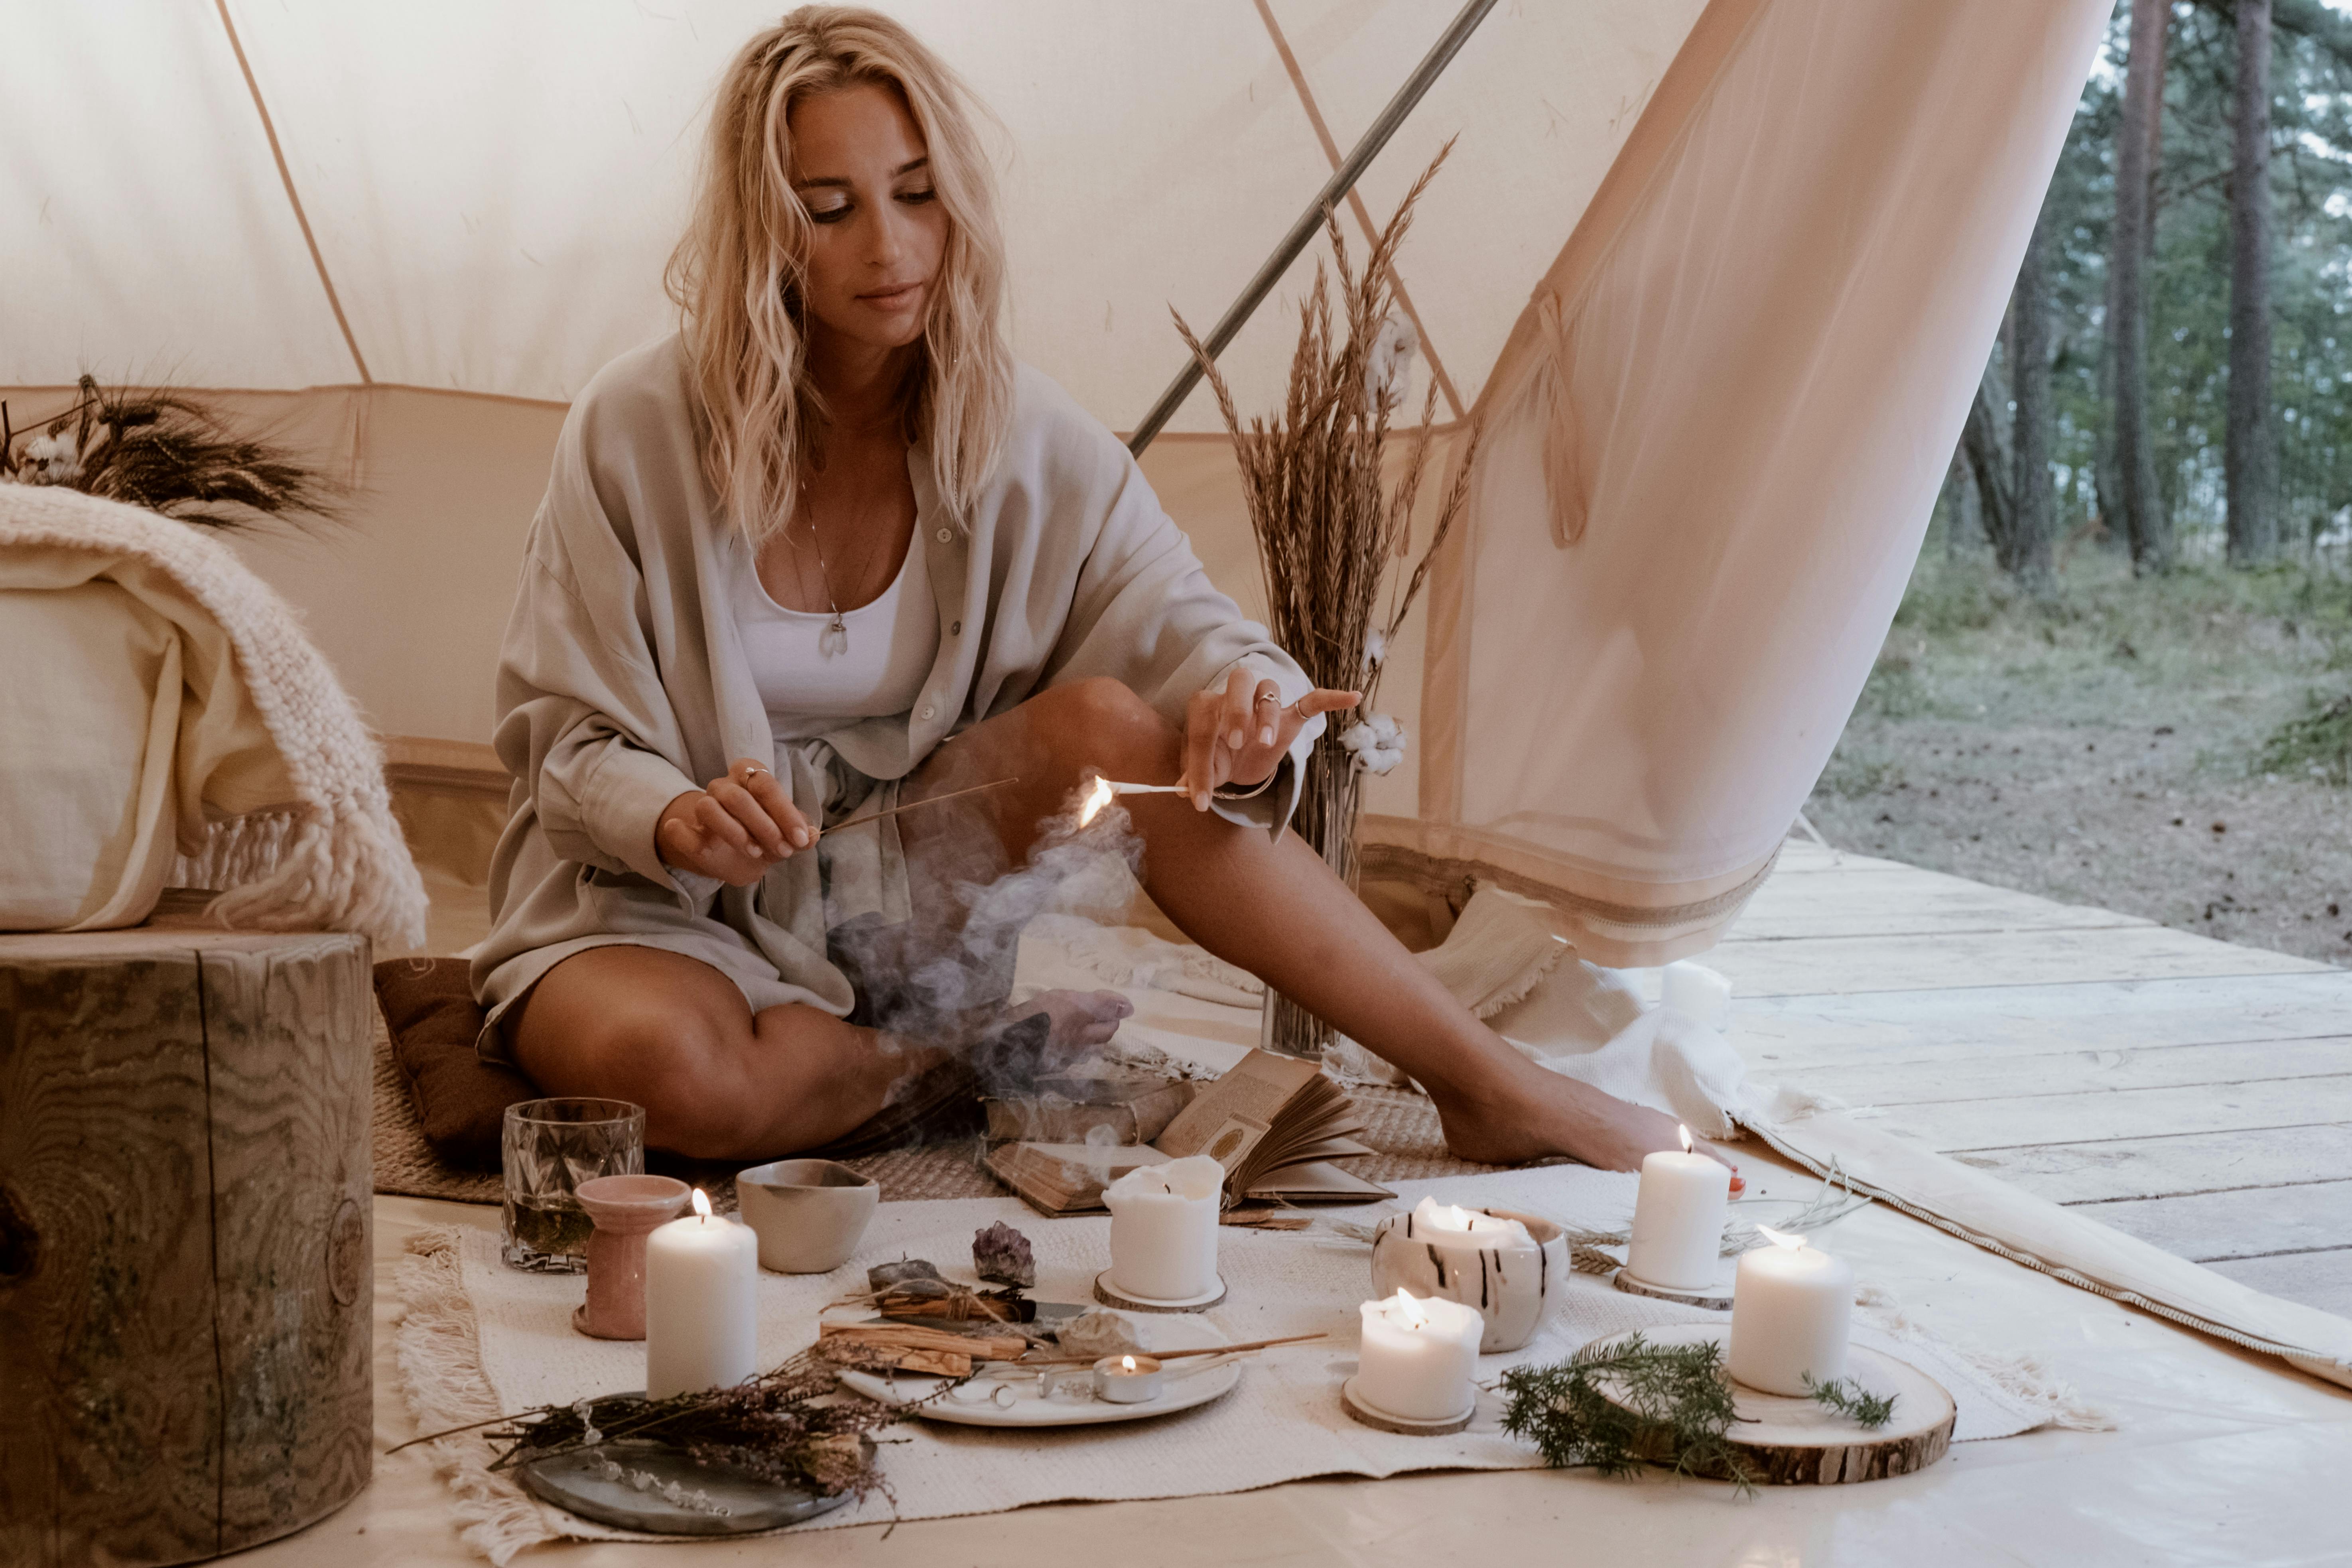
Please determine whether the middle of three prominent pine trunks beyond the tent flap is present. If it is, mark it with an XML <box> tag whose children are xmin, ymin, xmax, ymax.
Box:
<box><xmin>2108</xmin><ymin>0</ymin><xmax>2173</xmax><ymax>571</ymax></box>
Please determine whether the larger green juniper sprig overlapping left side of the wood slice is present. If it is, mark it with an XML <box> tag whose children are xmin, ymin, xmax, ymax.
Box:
<box><xmin>1503</xmin><ymin>1333</ymin><xmax>1755</xmax><ymax>1495</ymax></box>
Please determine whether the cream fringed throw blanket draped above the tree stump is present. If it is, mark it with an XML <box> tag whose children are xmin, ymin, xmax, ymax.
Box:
<box><xmin>0</xmin><ymin>484</ymin><xmax>426</xmax><ymax>943</ymax></box>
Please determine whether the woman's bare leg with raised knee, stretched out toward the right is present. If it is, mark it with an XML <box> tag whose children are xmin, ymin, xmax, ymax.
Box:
<box><xmin>901</xmin><ymin>680</ymin><xmax>1740</xmax><ymax>1171</ymax></box>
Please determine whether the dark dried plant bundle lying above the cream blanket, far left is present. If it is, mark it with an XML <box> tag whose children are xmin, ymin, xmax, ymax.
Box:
<box><xmin>0</xmin><ymin>376</ymin><xmax>343</xmax><ymax>529</ymax></box>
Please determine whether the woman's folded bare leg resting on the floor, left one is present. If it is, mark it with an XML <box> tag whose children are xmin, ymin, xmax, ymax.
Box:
<box><xmin>506</xmin><ymin>945</ymin><xmax>943</xmax><ymax>1159</ymax></box>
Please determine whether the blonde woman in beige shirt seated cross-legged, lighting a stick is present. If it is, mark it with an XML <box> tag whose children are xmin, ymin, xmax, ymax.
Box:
<box><xmin>473</xmin><ymin>7</ymin><xmax>1731</xmax><ymax>1189</ymax></box>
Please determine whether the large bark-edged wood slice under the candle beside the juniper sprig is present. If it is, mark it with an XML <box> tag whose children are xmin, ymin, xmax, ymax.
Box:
<box><xmin>1602</xmin><ymin>1324</ymin><xmax>1957</xmax><ymax>1486</ymax></box>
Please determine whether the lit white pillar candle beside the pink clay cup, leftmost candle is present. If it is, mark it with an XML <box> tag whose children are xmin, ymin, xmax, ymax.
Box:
<box><xmin>644</xmin><ymin>1187</ymin><xmax>760</xmax><ymax>1399</ymax></box>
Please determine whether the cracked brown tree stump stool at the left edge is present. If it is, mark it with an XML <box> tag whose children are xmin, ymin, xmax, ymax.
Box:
<box><xmin>0</xmin><ymin>896</ymin><xmax>374</xmax><ymax>1568</ymax></box>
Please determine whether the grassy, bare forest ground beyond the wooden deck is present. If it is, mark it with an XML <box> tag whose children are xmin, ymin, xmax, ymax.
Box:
<box><xmin>1806</xmin><ymin>524</ymin><xmax>2352</xmax><ymax>964</ymax></box>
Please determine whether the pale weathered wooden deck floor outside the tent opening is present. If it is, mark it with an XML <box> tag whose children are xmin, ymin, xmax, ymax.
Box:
<box><xmin>1703</xmin><ymin>844</ymin><xmax>2352</xmax><ymax>1316</ymax></box>
